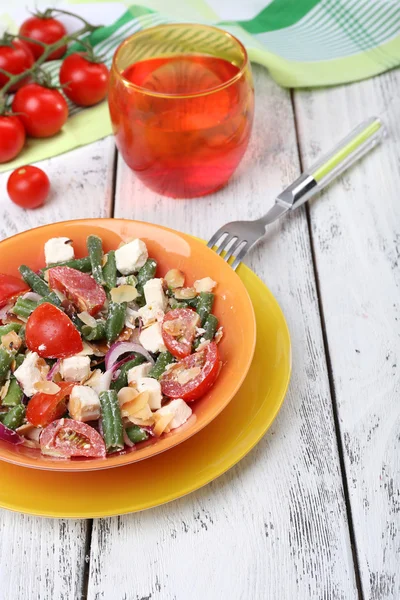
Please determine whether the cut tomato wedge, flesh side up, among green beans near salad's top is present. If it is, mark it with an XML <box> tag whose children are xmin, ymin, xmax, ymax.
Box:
<box><xmin>48</xmin><ymin>267</ymin><xmax>107</xmax><ymax>315</ymax></box>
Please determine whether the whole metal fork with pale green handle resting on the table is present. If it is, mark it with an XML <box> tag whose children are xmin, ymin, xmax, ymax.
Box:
<box><xmin>207</xmin><ymin>117</ymin><xmax>386</xmax><ymax>270</ymax></box>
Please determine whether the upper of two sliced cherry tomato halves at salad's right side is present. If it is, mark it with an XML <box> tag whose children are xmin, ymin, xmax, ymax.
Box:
<box><xmin>162</xmin><ymin>308</ymin><xmax>200</xmax><ymax>358</ymax></box>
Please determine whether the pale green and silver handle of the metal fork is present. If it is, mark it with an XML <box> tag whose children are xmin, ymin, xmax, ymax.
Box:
<box><xmin>276</xmin><ymin>117</ymin><xmax>386</xmax><ymax>210</ymax></box>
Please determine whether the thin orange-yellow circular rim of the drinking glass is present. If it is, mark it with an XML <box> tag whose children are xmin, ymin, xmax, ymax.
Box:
<box><xmin>111</xmin><ymin>23</ymin><xmax>249</xmax><ymax>99</ymax></box>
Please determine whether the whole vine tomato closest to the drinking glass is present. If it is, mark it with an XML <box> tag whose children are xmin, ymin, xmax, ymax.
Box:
<box><xmin>60</xmin><ymin>52</ymin><xmax>110</xmax><ymax>106</ymax></box>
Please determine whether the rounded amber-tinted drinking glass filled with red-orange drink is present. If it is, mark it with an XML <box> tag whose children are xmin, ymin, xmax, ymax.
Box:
<box><xmin>109</xmin><ymin>24</ymin><xmax>254</xmax><ymax>198</ymax></box>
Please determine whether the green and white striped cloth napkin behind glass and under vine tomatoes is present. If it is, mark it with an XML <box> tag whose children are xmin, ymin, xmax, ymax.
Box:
<box><xmin>0</xmin><ymin>0</ymin><xmax>400</xmax><ymax>171</ymax></box>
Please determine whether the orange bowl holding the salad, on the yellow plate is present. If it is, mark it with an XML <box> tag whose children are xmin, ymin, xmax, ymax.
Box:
<box><xmin>0</xmin><ymin>219</ymin><xmax>256</xmax><ymax>471</ymax></box>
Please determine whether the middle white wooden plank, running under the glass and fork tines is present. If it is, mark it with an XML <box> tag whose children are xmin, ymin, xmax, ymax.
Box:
<box><xmin>88</xmin><ymin>68</ymin><xmax>356</xmax><ymax>600</ymax></box>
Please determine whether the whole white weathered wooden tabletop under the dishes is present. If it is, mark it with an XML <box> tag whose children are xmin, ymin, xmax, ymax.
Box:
<box><xmin>0</xmin><ymin>67</ymin><xmax>400</xmax><ymax>600</ymax></box>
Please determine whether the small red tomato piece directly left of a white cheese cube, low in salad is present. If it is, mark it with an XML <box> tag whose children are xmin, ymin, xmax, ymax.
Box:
<box><xmin>26</xmin><ymin>381</ymin><xmax>76</xmax><ymax>427</ymax></box>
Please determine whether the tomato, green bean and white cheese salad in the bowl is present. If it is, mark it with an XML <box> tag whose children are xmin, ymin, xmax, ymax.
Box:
<box><xmin>0</xmin><ymin>235</ymin><xmax>222</xmax><ymax>459</ymax></box>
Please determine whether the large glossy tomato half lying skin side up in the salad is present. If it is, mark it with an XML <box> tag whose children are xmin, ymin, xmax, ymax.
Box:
<box><xmin>25</xmin><ymin>302</ymin><xmax>83</xmax><ymax>358</ymax></box>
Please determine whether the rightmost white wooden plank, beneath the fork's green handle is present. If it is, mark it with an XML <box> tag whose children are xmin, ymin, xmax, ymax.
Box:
<box><xmin>295</xmin><ymin>71</ymin><xmax>400</xmax><ymax>600</ymax></box>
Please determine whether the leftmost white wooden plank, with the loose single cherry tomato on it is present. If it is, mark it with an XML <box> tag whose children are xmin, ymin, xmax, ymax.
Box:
<box><xmin>0</xmin><ymin>138</ymin><xmax>114</xmax><ymax>600</ymax></box>
